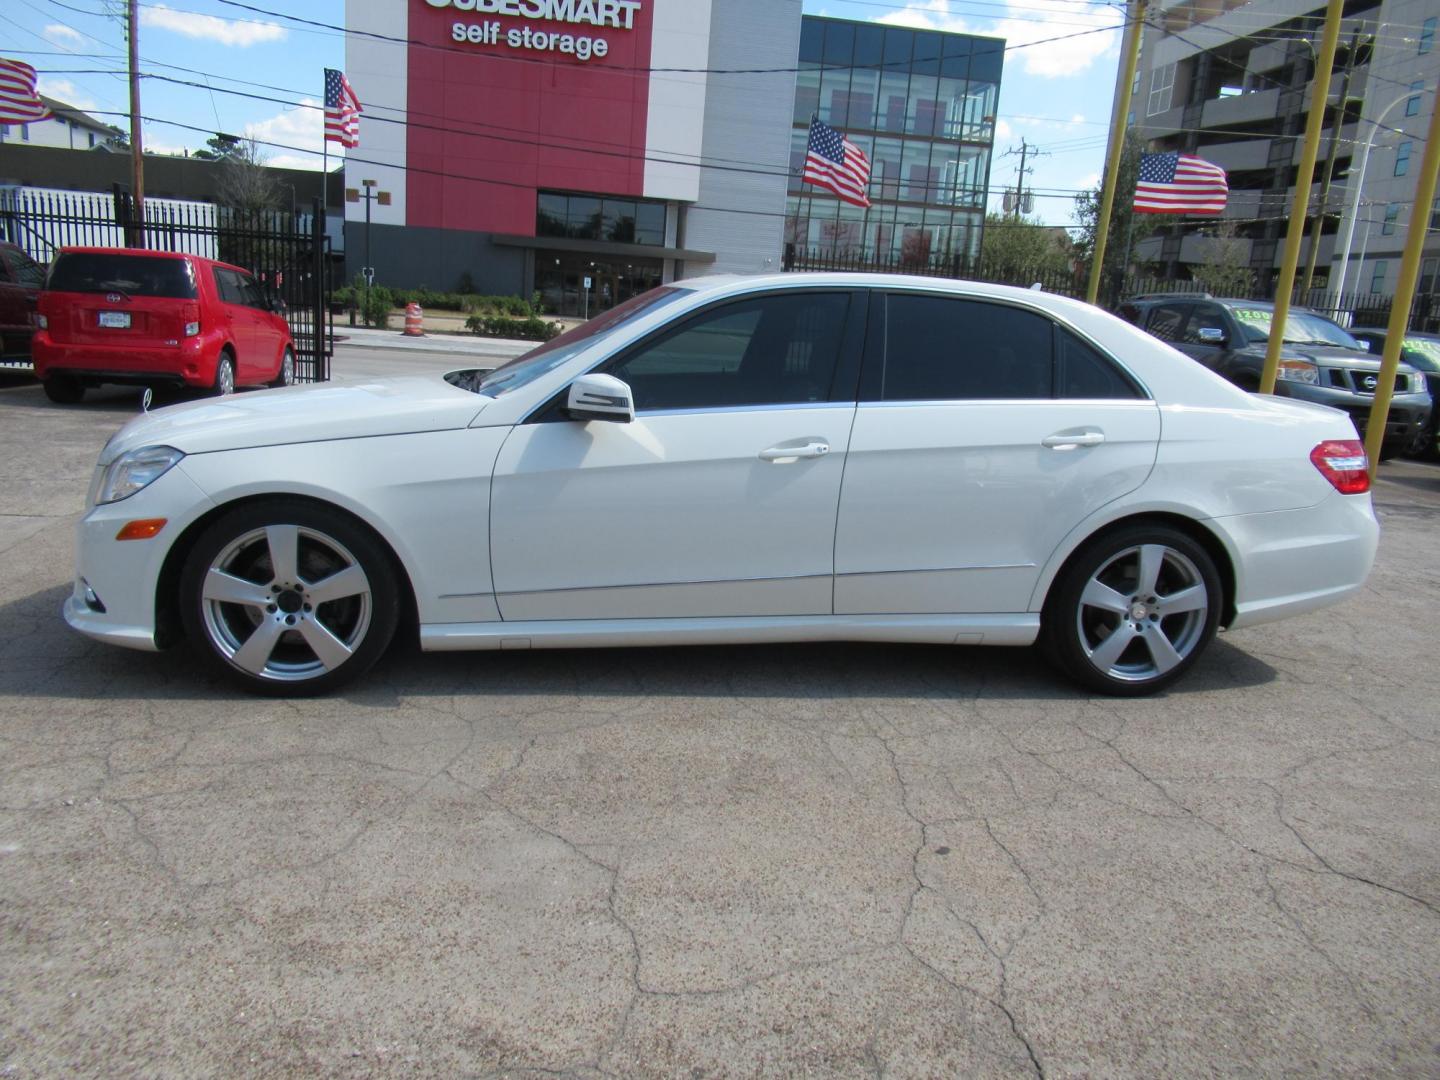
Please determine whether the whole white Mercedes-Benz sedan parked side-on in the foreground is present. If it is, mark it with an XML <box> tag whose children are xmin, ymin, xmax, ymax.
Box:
<box><xmin>65</xmin><ymin>274</ymin><xmax>1378</xmax><ymax>694</ymax></box>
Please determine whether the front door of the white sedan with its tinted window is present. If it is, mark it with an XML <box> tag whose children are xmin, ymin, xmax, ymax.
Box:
<box><xmin>491</xmin><ymin>288</ymin><xmax>864</xmax><ymax>621</ymax></box>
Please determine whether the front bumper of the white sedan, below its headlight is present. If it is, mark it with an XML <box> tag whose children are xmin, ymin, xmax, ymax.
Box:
<box><xmin>62</xmin><ymin>462</ymin><xmax>215</xmax><ymax>652</ymax></box>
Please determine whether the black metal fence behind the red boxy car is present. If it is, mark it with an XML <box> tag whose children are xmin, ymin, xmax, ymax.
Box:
<box><xmin>0</xmin><ymin>186</ymin><xmax>334</xmax><ymax>383</ymax></box>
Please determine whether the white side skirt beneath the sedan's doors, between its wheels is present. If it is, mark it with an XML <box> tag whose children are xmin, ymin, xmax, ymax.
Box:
<box><xmin>420</xmin><ymin>612</ymin><xmax>1040</xmax><ymax>652</ymax></box>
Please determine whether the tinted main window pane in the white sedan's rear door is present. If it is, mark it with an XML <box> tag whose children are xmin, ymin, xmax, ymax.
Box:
<box><xmin>880</xmin><ymin>294</ymin><xmax>1054</xmax><ymax>402</ymax></box>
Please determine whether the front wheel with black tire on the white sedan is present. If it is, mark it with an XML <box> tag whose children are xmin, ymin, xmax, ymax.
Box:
<box><xmin>180</xmin><ymin>498</ymin><xmax>400</xmax><ymax>697</ymax></box>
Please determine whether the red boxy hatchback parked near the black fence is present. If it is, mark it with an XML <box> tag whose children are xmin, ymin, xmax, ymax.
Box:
<box><xmin>30</xmin><ymin>248</ymin><xmax>295</xmax><ymax>405</ymax></box>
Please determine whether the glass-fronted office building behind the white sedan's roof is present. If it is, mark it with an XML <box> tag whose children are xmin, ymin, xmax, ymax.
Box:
<box><xmin>785</xmin><ymin>16</ymin><xmax>1005</xmax><ymax>264</ymax></box>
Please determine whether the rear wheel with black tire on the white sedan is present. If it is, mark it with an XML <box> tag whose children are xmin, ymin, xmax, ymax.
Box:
<box><xmin>1041</xmin><ymin>524</ymin><xmax>1224</xmax><ymax>697</ymax></box>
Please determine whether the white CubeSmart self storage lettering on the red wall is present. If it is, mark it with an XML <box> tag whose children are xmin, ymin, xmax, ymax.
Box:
<box><xmin>425</xmin><ymin>0</ymin><xmax>641</xmax><ymax>60</ymax></box>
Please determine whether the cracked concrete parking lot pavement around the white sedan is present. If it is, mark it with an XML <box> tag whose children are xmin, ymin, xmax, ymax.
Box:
<box><xmin>0</xmin><ymin>348</ymin><xmax>1440</xmax><ymax>1077</ymax></box>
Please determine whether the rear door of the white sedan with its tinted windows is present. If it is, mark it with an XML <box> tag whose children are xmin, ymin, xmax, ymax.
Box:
<box><xmin>835</xmin><ymin>292</ymin><xmax>1161</xmax><ymax>615</ymax></box>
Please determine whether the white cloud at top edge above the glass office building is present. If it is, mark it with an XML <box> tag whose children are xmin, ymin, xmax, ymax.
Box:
<box><xmin>880</xmin><ymin>0</ymin><xmax>1122</xmax><ymax>79</ymax></box>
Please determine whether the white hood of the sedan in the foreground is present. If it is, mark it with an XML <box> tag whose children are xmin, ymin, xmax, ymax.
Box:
<box><xmin>99</xmin><ymin>374</ymin><xmax>488</xmax><ymax>465</ymax></box>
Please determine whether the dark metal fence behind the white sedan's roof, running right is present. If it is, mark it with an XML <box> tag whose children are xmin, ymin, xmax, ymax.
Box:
<box><xmin>783</xmin><ymin>245</ymin><xmax>1440</xmax><ymax>331</ymax></box>
